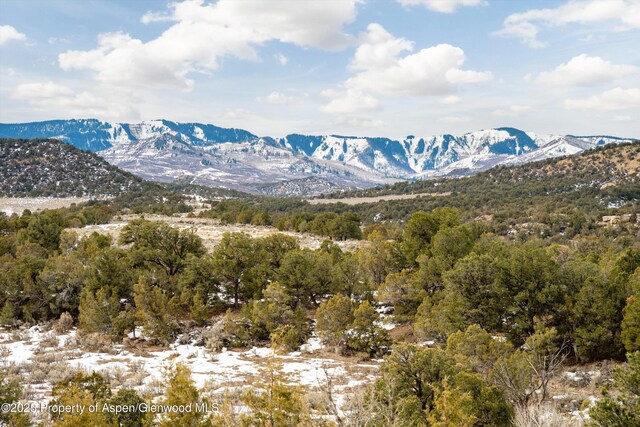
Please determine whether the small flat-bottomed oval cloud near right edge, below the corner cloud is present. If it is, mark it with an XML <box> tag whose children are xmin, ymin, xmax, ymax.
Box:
<box><xmin>536</xmin><ymin>54</ymin><xmax>639</xmax><ymax>86</ymax></box>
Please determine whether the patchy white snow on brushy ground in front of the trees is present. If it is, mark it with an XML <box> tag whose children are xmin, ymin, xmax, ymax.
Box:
<box><xmin>0</xmin><ymin>326</ymin><xmax>379</xmax><ymax>412</ymax></box>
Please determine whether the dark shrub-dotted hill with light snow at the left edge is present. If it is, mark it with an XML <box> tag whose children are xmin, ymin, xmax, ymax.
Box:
<box><xmin>0</xmin><ymin>139</ymin><xmax>143</xmax><ymax>197</ymax></box>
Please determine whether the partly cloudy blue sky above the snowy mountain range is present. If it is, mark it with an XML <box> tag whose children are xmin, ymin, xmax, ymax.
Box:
<box><xmin>0</xmin><ymin>0</ymin><xmax>640</xmax><ymax>138</ymax></box>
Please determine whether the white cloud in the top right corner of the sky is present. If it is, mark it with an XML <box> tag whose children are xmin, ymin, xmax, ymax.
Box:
<box><xmin>495</xmin><ymin>0</ymin><xmax>640</xmax><ymax>47</ymax></box>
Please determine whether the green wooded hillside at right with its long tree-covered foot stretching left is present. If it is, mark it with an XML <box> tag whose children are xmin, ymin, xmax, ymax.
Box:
<box><xmin>198</xmin><ymin>143</ymin><xmax>640</xmax><ymax>235</ymax></box>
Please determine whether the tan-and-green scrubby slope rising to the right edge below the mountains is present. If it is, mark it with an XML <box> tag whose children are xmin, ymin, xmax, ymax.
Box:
<box><xmin>316</xmin><ymin>142</ymin><xmax>640</xmax><ymax>226</ymax></box>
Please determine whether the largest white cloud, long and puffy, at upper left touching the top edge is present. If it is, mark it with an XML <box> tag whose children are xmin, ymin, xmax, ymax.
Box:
<box><xmin>58</xmin><ymin>0</ymin><xmax>359</xmax><ymax>90</ymax></box>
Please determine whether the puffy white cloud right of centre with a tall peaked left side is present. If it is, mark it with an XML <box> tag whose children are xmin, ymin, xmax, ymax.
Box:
<box><xmin>324</xmin><ymin>24</ymin><xmax>492</xmax><ymax>113</ymax></box>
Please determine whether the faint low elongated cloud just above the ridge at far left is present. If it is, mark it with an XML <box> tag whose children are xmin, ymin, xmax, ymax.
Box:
<box><xmin>12</xmin><ymin>81</ymin><xmax>139</xmax><ymax>119</ymax></box>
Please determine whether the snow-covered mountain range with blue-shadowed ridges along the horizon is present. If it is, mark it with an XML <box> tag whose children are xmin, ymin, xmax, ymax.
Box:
<box><xmin>0</xmin><ymin>119</ymin><xmax>634</xmax><ymax>196</ymax></box>
